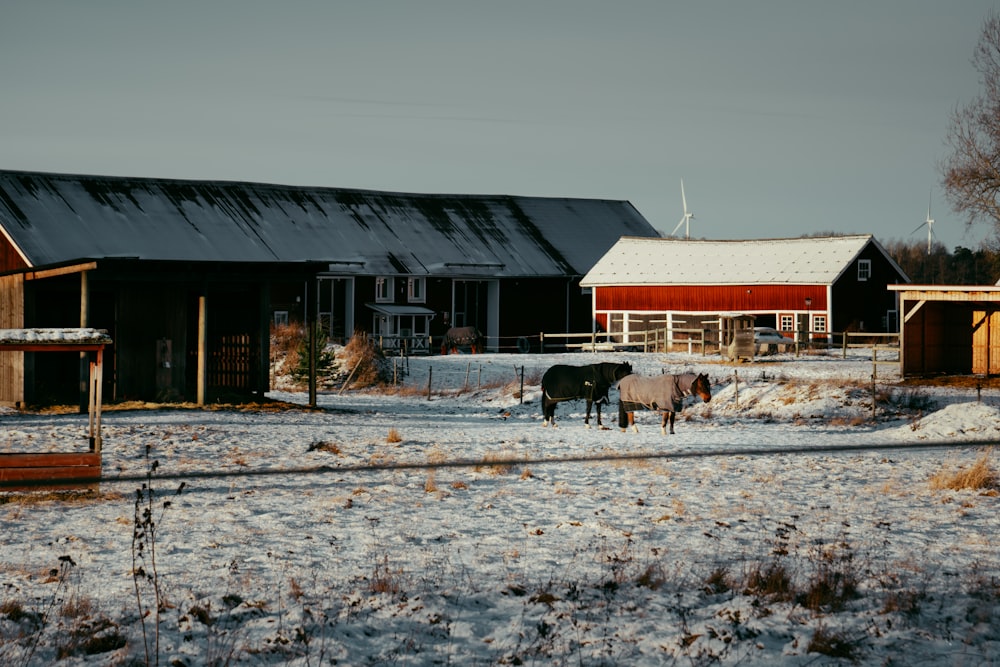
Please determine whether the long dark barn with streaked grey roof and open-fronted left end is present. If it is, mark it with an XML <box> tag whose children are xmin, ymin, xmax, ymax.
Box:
<box><xmin>0</xmin><ymin>171</ymin><xmax>657</xmax><ymax>404</ymax></box>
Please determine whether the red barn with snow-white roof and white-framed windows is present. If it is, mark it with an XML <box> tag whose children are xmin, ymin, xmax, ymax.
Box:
<box><xmin>581</xmin><ymin>235</ymin><xmax>909</xmax><ymax>350</ymax></box>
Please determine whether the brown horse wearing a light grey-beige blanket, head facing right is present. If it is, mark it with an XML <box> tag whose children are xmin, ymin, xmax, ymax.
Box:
<box><xmin>618</xmin><ymin>373</ymin><xmax>712</xmax><ymax>435</ymax></box>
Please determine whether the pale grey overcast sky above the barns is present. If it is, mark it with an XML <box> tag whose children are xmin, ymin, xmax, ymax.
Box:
<box><xmin>0</xmin><ymin>0</ymin><xmax>1000</xmax><ymax>250</ymax></box>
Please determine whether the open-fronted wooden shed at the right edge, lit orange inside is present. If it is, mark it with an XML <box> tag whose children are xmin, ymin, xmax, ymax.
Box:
<box><xmin>889</xmin><ymin>285</ymin><xmax>1000</xmax><ymax>377</ymax></box>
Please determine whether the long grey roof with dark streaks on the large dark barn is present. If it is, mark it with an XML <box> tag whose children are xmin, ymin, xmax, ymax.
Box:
<box><xmin>0</xmin><ymin>170</ymin><xmax>657</xmax><ymax>276</ymax></box>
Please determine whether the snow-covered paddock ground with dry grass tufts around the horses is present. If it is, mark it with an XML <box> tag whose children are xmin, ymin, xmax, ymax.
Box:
<box><xmin>0</xmin><ymin>352</ymin><xmax>1000</xmax><ymax>665</ymax></box>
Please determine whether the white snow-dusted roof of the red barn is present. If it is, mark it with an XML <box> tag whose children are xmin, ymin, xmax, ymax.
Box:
<box><xmin>581</xmin><ymin>234</ymin><xmax>902</xmax><ymax>287</ymax></box>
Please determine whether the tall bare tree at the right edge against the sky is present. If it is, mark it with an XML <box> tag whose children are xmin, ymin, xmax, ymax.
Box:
<box><xmin>941</xmin><ymin>12</ymin><xmax>1000</xmax><ymax>236</ymax></box>
